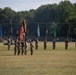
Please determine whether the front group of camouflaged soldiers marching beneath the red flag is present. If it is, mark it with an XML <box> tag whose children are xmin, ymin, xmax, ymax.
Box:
<box><xmin>14</xmin><ymin>38</ymin><xmax>34</xmax><ymax>55</ymax></box>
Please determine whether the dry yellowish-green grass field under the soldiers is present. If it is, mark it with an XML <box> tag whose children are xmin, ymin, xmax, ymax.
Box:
<box><xmin>0</xmin><ymin>42</ymin><xmax>76</xmax><ymax>75</ymax></box>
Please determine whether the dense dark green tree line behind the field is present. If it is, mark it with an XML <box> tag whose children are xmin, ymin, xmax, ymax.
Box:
<box><xmin>0</xmin><ymin>0</ymin><xmax>76</xmax><ymax>37</ymax></box>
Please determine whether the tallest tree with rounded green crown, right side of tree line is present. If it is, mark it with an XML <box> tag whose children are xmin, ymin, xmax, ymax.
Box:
<box><xmin>57</xmin><ymin>0</ymin><xmax>76</xmax><ymax>36</ymax></box>
